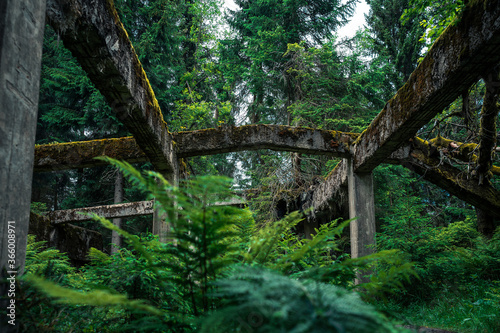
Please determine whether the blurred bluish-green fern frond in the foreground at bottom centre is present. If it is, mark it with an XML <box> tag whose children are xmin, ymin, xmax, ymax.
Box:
<box><xmin>201</xmin><ymin>267</ymin><xmax>407</xmax><ymax>333</ymax></box>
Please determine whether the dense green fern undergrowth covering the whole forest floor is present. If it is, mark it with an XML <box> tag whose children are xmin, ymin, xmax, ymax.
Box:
<box><xmin>19</xmin><ymin>160</ymin><xmax>500</xmax><ymax>332</ymax></box>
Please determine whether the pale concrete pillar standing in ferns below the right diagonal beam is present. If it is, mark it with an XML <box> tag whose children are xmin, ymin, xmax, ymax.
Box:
<box><xmin>348</xmin><ymin>159</ymin><xmax>375</xmax><ymax>283</ymax></box>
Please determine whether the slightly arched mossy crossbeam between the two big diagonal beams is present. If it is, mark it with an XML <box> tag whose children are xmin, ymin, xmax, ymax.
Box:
<box><xmin>172</xmin><ymin>125</ymin><xmax>359</xmax><ymax>157</ymax></box>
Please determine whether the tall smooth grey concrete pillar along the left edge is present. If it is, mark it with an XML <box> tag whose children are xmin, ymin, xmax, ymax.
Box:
<box><xmin>0</xmin><ymin>0</ymin><xmax>45</xmax><ymax>332</ymax></box>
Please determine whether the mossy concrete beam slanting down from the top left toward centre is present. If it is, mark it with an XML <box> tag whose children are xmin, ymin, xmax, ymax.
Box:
<box><xmin>47</xmin><ymin>0</ymin><xmax>178</xmax><ymax>174</ymax></box>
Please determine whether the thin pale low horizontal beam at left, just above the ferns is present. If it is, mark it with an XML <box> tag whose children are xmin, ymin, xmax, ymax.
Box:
<box><xmin>48</xmin><ymin>200</ymin><xmax>153</xmax><ymax>224</ymax></box>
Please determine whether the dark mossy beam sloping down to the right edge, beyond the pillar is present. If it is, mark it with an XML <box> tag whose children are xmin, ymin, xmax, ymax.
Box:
<box><xmin>401</xmin><ymin>138</ymin><xmax>500</xmax><ymax>218</ymax></box>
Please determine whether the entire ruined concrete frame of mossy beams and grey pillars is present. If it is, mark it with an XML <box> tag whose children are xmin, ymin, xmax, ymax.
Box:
<box><xmin>0</xmin><ymin>0</ymin><xmax>500</xmax><ymax>308</ymax></box>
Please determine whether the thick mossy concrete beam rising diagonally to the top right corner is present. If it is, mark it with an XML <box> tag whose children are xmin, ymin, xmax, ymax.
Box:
<box><xmin>355</xmin><ymin>0</ymin><xmax>500</xmax><ymax>172</ymax></box>
